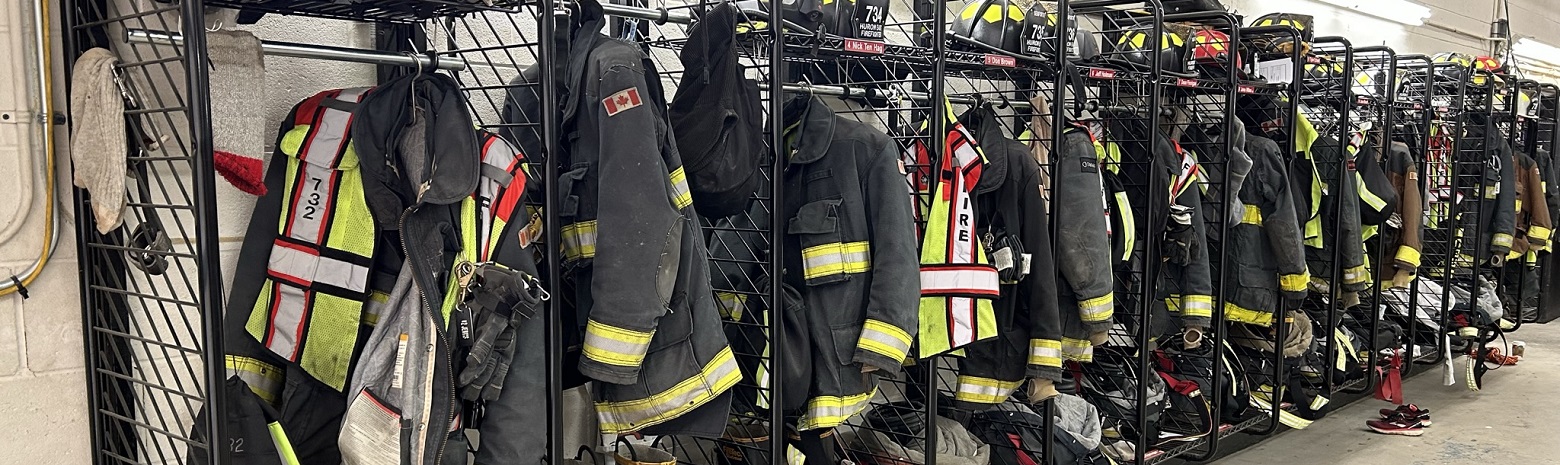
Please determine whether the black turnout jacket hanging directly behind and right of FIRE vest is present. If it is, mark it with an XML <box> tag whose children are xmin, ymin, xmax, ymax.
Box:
<box><xmin>955</xmin><ymin>108</ymin><xmax>1062</xmax><ymax>410</ymax></box>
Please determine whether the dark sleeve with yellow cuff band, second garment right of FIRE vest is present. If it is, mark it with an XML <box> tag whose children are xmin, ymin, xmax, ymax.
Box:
<box><xmin>1051</xmin><ymin>131</ymin><xmax>1115</xmax><ymax>332</ymax></box>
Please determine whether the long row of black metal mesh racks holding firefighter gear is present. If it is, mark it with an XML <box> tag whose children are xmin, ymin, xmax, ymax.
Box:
<box><xmin>66</xmin><ymin>0</ymin><xmax>1522</xmax><ymax>465</ymax></box>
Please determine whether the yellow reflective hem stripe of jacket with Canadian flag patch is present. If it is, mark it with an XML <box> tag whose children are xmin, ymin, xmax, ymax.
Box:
<box><xmin>596</xmin><ymin>348</ymin><xmax>743</xmax><ymax>434</ymax></box>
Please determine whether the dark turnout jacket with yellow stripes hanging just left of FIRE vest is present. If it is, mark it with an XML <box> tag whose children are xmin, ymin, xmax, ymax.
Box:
<box><xmin>714</xmin><ymin>97</ymin><xmax>920</xmax><ymax>431</ymax></box>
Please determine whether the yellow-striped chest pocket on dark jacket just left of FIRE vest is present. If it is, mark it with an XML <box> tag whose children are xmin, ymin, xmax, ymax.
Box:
<box><xmin>786</xmin><ymin>198</ymin><xmax>872</xmax><ymax>286</ymax></box>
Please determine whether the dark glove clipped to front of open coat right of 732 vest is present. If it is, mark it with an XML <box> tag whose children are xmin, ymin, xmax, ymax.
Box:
<box><xmin>456</xmin><ymin>267</ymin><xmax>548</xmax><ymax>401</ymax></box>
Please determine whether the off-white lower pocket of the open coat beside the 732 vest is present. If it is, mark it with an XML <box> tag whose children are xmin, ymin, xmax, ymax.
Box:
<box><xmin>337</xmin><ymin>387</ymin><xmax>412</xmax><ymax>465</ymax></box>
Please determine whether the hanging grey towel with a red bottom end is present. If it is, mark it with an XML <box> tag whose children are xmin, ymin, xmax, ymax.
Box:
<box><xmin>206</xmin><ymin>31</ymin><xmax>275</xmax><ymax>195</ymax></box>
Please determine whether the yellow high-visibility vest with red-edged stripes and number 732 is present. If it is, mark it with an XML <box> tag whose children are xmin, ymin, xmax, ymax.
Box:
<box><xmin>245</xmin><ymin>87</ymin><xmax>379</xmax><ymax>390</ymax></box>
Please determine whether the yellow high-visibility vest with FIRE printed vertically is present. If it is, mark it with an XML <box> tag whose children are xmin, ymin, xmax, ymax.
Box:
<box><xmin>908</xmin><ymin>105</ymin><xmax>1002</xmax><ymax>357</ymax></box>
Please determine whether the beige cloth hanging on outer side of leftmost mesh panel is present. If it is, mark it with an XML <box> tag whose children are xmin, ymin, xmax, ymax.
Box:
<box><xmin>70</xmin><ymin>48</ymin><xmax>126</xmax><ymax>234</ymax></box>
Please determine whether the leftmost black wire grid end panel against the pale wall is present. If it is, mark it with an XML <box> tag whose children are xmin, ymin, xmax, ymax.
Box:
<box><xmin>62</xmin><ymin>0</ymin><xmax>229</xmax><ymax>463</ymax></box>
